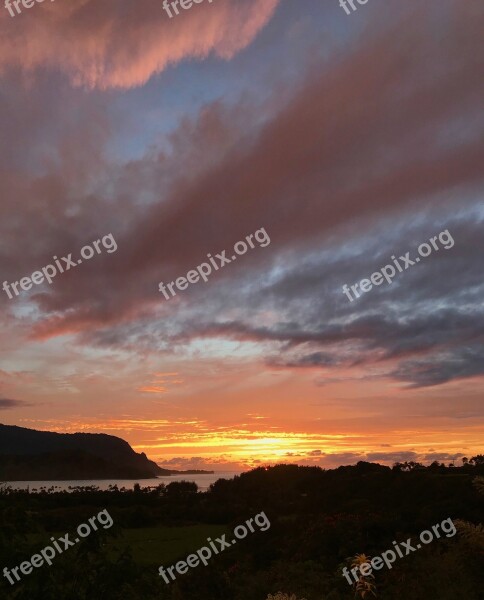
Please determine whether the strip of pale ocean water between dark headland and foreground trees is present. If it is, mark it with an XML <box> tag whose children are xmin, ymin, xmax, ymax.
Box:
<box><xmin>2</xmin><ymin>471</ymin><xmax>240</xmax><ymax>492</ymax></box>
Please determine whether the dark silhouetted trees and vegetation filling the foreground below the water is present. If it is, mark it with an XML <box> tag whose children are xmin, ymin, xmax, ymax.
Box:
<box><xmin>0</xmin><ymin>457</ymin><xmax>484</xmax><ymax>600</ymax></box>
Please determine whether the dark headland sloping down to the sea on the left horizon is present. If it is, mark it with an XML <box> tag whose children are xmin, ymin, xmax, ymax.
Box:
<box><xmin>0</xmin><ymin>424</ymin><xmax>213</xmax><ymax>481</ymax></box>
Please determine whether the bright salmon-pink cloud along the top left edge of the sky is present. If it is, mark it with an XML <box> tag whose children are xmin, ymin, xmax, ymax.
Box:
<box><xmin>0</xmin><ymin>0</ymin><xmax>279</xmax><ymax>89</ymax></box>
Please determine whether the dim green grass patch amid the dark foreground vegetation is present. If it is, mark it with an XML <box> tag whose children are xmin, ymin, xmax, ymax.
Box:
<box><xmin>107</xmin><ymin>524</ymin><xmax>228</xmax><ymax>566</ymax></box>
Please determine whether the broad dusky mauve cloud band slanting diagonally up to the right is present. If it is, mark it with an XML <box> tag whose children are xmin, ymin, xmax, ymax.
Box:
<box><xmin>21</xmin><ymin>3</ymin><xmax>483</xmax><ymax>346</ymax></box>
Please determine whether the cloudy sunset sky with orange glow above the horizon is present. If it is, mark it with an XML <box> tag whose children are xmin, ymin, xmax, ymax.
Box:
<box><xmin>0</xmin><ymin>0</ymin><xmax>484</xmax><ymax>471</ymax></box>
